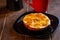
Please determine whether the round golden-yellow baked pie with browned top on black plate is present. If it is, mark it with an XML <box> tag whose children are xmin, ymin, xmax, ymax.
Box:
<box><xmin>23</xmin><ymin>13</ymin><xmax>50</xmax><ymax>30</ymax></box>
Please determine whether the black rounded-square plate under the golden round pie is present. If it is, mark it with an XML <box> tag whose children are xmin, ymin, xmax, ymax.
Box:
<box><xmin>13</xmin><ymin>11</ymin><xmax>59</xmax><ymax>37</ymax></box>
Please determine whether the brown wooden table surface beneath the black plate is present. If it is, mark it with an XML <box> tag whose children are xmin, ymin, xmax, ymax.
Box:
<box><xmin>0</xmin><ymin>0</ymin><xmax>60</xmax><ymax>40</ymax></box>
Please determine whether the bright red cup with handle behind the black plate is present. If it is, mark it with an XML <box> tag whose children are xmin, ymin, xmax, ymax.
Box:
<box><xmin>24</xmin><ymin>0</ymin><xmax>48</xmax><ymax>12</ymax></box>
